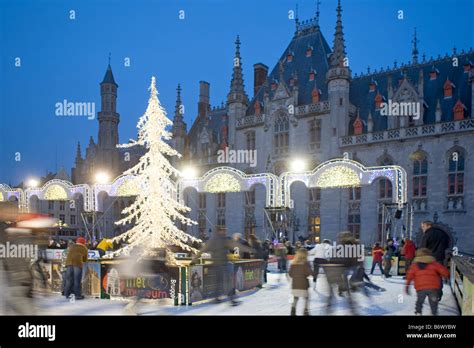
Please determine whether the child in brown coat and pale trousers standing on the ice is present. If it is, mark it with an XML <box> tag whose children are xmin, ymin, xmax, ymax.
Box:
<box><xmin>288</xmin><ymin>248</ymin><xmax>313</xmax><ymax>315</ymax></box>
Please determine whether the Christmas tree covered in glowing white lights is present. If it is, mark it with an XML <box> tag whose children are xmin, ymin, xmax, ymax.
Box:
<box><xmin>112</xmin><ymin>77</ymin><xmax>200</xmax><ymax>262</ymax></box>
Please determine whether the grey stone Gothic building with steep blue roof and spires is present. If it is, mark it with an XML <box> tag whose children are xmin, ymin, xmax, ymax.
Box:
<box><xmin>173</xmin><ymin>3</ymin><xmax>474</xmax><ymax>253</ymax></box>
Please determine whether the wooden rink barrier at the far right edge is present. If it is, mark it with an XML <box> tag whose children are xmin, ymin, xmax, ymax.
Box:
<box><xmin>450</xmin><ymin>256</ymin><xmax>474</xmax><ymax>315</ymax></box>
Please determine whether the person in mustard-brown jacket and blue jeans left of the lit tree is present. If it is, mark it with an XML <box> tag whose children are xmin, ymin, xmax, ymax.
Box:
<box><xmin>64</xmin><ymin>237</ymin><xmax>88</xmax><ymax>300</ymax></box>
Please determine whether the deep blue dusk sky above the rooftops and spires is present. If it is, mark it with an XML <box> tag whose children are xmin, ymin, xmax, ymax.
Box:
<box><xmin>0</xmin><ymin>0</ymin><xmax>474</xmax><ymax>185</ymax></box>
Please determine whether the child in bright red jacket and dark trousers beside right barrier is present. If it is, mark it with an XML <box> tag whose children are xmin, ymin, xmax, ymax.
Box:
<box><xmin>405</xmin><ymin>248</ymin><xmax>449</xmax><ymax>315</ymax></box>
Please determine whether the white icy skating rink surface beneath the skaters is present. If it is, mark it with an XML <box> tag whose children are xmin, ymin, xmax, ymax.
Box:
<box><xmin>33</xmin><ymin>273</ymin><xmax>459</xmax><ymax>315</ymax></box>
